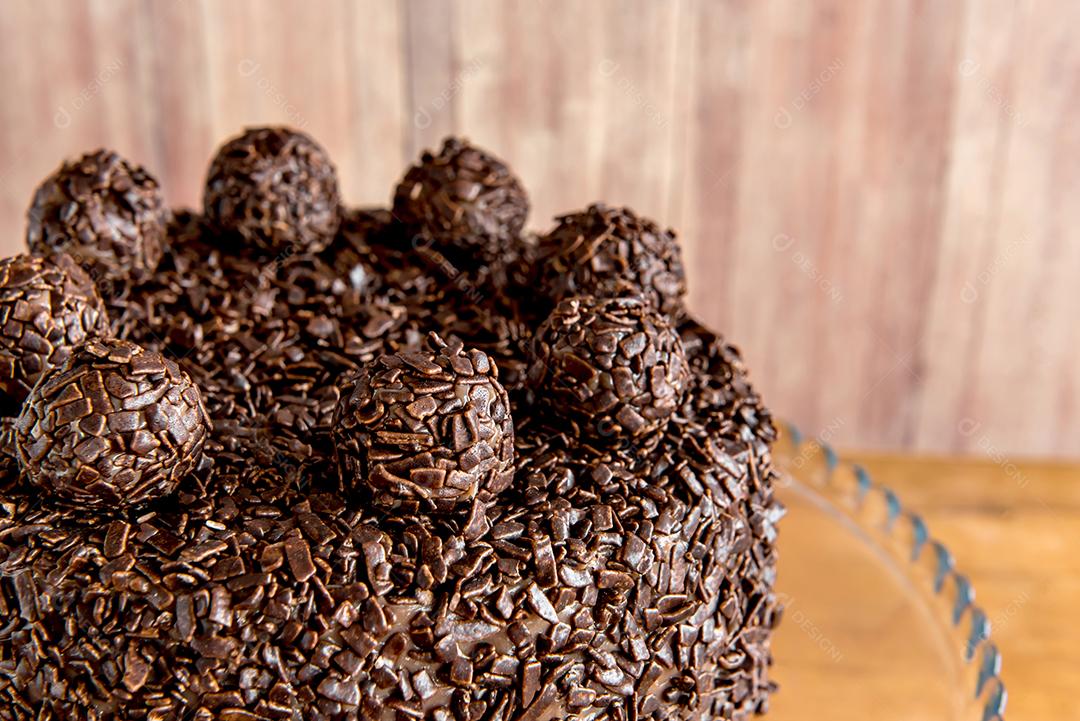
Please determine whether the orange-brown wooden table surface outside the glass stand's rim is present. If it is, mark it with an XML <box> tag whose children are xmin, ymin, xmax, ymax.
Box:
<box><xmin>842</xmin><ymin>453</ymin><xmax>1080</xmax><ymax>721</ymax></box>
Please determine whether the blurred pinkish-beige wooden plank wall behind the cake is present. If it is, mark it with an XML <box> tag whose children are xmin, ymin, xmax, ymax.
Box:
<box><xmin>0</xmin><ymin>0</ymin><xmax>1080</xmax><ymax>464</ymax></box>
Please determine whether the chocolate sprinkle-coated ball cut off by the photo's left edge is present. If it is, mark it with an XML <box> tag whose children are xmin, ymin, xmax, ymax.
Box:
<box><xmin>0</xmin><ymin>253</ymin><xmax>109</xmax><ymax>406</ymax></box>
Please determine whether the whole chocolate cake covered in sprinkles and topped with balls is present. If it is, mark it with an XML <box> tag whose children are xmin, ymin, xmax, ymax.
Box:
<box><xmin>0</xmin><ymin>128</ymin><xmax>782</xmax><ymax>721</ymax></box>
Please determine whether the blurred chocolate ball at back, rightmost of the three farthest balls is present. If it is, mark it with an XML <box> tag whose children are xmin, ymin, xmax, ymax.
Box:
<box><xmin>394</xmin><ymin>138</ymin><xmax>529</xmax><ymax>261</ymax></box>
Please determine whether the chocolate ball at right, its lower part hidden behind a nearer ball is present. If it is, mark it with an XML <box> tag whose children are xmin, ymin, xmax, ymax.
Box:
<box><xmin>538</xmin><ymin>205</ymin><xmax>686</xmax><ymax>316</ymax></box>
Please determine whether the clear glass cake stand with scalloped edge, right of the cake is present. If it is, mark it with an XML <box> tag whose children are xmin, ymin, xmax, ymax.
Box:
<box><xmin>766</xmin><ymin>425</ymin><xmax>1005</xmax><ymax>721</ymax></box>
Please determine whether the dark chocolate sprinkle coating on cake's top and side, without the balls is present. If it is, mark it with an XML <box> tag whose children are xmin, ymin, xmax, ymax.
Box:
<box><xmin>0</xmin><ymin>133</ymin><xmax>782</xmax><ymax>721</ymax></box>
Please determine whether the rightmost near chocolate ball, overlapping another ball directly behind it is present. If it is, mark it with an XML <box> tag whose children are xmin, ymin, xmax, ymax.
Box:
<box><xmin>528</xmin><ymin>296</ymin><xmax>690</xmax><ymax>443</ymax></box>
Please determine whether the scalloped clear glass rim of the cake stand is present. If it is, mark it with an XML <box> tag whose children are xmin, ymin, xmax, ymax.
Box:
<box><xmin>773</xmin><ymin>422</ymin><xmax>1008</xmax><ymax>721</ymax></box>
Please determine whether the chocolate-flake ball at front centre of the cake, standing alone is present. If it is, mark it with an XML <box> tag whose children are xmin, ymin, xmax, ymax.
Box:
<box><xmin>333</xmin><ymin>335</ymin><xmax>514</xmax><ymax>511</ymax></box>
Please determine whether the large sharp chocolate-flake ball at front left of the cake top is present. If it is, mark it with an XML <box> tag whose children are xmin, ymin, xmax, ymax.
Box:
<box><xmin>15</xmin><ymin>339</ymin><xmax>210</xmax><ymax>508</ymax></box>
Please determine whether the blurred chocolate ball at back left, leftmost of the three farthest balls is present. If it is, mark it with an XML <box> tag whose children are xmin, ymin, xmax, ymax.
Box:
<box><xmin>26</xmin><ymin>150</ymin><xmax>168</xmax><ymax>283</ymax></box>
